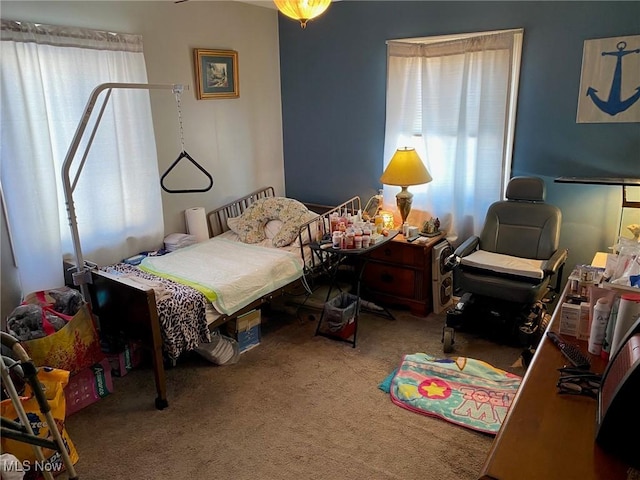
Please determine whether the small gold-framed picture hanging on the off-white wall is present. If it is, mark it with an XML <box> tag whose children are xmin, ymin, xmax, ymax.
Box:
<box><xmin>193</xmin><ymin>48</ymin><xmax>240</xmax><ymax>100</ymax></box>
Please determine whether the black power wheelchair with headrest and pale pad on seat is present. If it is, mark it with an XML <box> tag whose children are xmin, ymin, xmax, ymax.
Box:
<box><xmin>442</xmin><ymin>177</ymin><xmax>568</xmax><ymax>353</ymax></box>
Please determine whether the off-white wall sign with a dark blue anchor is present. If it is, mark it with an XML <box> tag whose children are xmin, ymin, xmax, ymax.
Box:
<box><xmin>576</xmin><ymin>35</ymin><xmax>640</xmax><ymax>123</ymax></box>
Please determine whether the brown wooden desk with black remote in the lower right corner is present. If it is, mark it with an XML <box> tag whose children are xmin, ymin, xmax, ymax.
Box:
<box><xmin>480</xmin><ymin>288</ymin><xmax>627</xmax><ymax>480</ymax></box>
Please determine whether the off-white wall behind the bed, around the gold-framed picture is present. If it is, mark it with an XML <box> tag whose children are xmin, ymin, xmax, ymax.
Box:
<box><xmin>0</xmin><ymin>0</ymin><xmax>285</xmax><ymax>317</ymax></box>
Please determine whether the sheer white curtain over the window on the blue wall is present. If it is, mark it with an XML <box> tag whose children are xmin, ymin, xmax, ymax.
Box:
<box><xmin>384</xmin><ymin>30</ymin><xmax>523</xmax><ymax>244</ymax></box>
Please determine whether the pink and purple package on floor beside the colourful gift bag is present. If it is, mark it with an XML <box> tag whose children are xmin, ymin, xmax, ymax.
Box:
<box><xmin>64</xmin><ymin>358</ymin><xmax>113</xmax><ymax>416</ymax></box>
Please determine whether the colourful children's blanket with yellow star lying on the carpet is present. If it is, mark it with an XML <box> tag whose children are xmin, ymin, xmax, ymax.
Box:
<box><xmin>379</xmin><ymin>353</ymin><xmax>522</xmax><ymax>434</ymax></box>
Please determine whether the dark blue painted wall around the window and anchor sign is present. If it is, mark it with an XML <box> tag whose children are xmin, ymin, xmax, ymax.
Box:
<box><xmin>279</xmin><ymin>0</ymin><xmax>640</xmax><ymax>270</ymax></box>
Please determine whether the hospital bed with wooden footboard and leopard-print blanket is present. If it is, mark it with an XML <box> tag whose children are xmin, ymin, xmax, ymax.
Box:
<box><xmin>65</xmin><ymin>187</ymin><xmax>361</xmax><ymax>409</ymax></box>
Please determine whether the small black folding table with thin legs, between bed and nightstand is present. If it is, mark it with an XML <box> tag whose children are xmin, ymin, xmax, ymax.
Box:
<box><xmin>309</xmin><ymin>230</ymin><xmax>398</xmax><ymax>348</ymax></box>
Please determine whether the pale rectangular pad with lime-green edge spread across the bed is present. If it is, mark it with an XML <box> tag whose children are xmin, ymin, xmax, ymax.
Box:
<box><xmin>140</xmin><ymin>237</ymin><xmax>303</xmax><ymax>314</ymax></box>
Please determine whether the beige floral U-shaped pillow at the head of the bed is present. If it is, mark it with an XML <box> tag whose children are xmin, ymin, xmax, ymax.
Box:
<box><xmin>230</xmin><ymin>197</ymin><xmax>316</xmax><ymax>247</ymax></box>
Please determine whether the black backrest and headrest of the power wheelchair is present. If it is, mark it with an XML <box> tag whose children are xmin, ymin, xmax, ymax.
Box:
<box><xmin>480</xmin><ymin>177</ymin><xmax>562</xmax><ymax>260</ymax></box>
